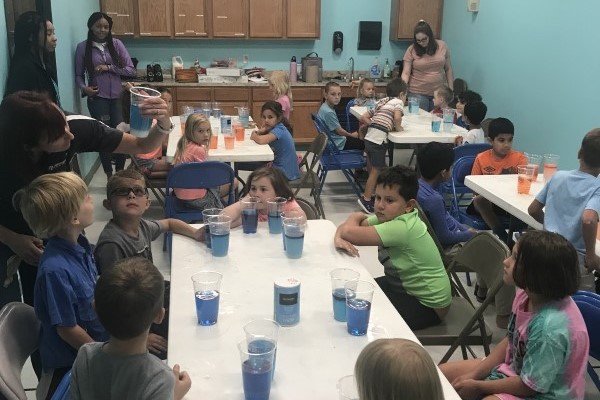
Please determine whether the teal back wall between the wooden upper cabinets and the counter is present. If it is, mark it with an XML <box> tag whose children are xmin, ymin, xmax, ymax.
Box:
<box><xmin>124</xmin><ymin>0</ymin><xmax>406</xmax><ymax>70</ymax></box>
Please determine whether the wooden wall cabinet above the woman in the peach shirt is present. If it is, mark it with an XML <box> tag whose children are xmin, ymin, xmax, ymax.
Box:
<box><xmin>390</xmin><ymin>0</ymin><xmax>444</xmax><ymax>40</ymax></box>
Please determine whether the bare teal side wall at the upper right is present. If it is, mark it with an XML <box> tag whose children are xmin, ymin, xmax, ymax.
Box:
<box><xmin>442</xmin><ymin>0</ymin><xmax>600</xmax><ymax>169</ymax></box>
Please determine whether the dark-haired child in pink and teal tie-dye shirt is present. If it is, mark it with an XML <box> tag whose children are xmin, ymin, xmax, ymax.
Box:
<box><xmin>440</xmin><ymin>231</ymin><xmax>589</xmax><ymax>399</ymax></box>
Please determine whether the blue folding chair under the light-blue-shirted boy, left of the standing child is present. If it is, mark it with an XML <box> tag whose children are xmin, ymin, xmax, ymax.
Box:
<box><xmin>312</xmin><ymin>113</ymin><xmax>367</xmax><ymax>196</ymax></box>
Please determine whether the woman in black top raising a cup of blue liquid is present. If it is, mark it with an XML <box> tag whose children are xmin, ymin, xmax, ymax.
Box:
<box><xmin>0</xmin><ymin>91</ymin><xmax>173</xmax><ymax>308</ymax></box>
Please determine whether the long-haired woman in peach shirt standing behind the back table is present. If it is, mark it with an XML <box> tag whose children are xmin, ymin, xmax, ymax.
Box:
<box><xmin>402</xmin><ymin>20</ymin><xmax>454</xmax><ymax>111</ymax></box>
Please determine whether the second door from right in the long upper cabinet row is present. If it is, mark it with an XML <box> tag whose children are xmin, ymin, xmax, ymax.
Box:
<box><xmin>249</xmin><ymin>0</ymin><xmax>284</xmax><ymax>38</ymax></box>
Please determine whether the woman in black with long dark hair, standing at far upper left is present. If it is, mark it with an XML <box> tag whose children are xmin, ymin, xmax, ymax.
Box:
<box><xmin>4</xmin><ymin>11</ymin><xmax>60</xmax><ymax>105</ymax></box>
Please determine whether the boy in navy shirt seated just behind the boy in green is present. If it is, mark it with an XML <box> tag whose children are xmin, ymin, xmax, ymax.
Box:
<box><xmin>417</xmin><ymin>142</ymin><xmax>515</xmax><ymax>329</ymax></box>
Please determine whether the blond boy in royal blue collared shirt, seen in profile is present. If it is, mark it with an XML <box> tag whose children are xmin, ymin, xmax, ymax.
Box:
<box><xmin>14</xmin><ymin>172</ymin><xmax>107</xmax><ymax>398</ymax></box>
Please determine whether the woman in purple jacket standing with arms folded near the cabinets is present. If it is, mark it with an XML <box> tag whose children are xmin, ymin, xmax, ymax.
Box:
<box><xmin>75</xmin><ymin>12</ymin><xmax>136</xmax><ymax>177</ymax></box>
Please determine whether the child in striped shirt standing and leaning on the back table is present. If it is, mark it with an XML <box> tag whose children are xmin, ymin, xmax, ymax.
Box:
<box><xmin>358</xmin><ymin>78</ymin><xmax>407</xmax><ymax>214</ymax></box>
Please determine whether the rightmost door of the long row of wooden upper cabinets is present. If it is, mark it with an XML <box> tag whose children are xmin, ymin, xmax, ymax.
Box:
<box><xmin>287</xmin><ymin>0</ymin><xmax>321</xmax><ymax>39</ymax></box>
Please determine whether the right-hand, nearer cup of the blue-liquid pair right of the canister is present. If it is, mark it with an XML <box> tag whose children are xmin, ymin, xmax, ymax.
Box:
<box><xmin>344</xmin><ymin>281</ymin><xmax>375</xmax><ymax>336</ymax></box>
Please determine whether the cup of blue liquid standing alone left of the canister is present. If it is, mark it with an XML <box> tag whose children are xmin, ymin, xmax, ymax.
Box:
<box><xmin>192</xmin><ymin>271</ymin><xmax>223</xmax><ymax>326</ymax></box>
